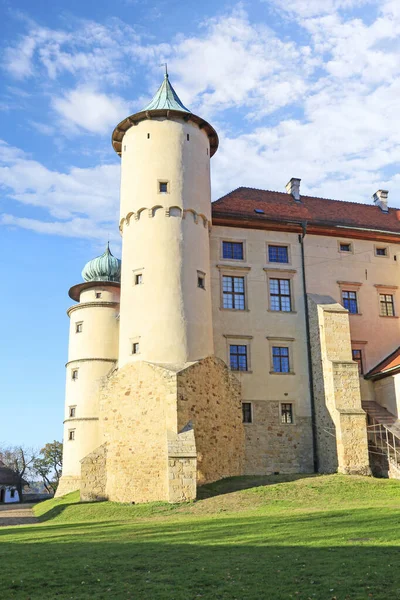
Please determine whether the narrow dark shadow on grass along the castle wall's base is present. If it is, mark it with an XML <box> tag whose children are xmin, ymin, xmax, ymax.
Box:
<box><xmin>197</xmin><ymin>473</ymin><xmax>320</xmax><ymax>500</ymax></box>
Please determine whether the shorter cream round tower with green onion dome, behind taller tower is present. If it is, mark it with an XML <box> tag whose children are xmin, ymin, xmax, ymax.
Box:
<box><xmin>57</xmin><ymin>245</ymin><xmax>121</xmax><ymax>495</ymax></box>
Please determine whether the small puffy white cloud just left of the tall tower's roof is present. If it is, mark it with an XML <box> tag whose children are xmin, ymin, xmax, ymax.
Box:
<box><xmin>52</xmin><ymin>87</ymin><xmax>130</xmax><ymax>133</ymax></box>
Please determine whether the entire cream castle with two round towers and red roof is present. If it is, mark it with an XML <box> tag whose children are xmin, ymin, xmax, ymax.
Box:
<box><xmin>58</xmin><ymin>75</ymin><xmax>400</xmax><ymax>502</ymax></box>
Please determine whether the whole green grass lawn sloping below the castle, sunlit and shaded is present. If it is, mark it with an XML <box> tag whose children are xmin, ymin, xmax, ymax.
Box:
<box><xmin>0</xmin><ymin>475</ymin><xmax>400</xmax><ymax>600</ymax></box>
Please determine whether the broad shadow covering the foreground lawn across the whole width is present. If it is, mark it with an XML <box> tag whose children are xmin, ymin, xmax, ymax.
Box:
<box><xmin>0</xmin><ymin>509</ymin><xmax>400</xmax><ymax>600</ymax></box>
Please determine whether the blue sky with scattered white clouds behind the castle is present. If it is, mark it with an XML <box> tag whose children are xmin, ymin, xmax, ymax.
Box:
<box><xmin>0</xmin><ymin>0</ymin><xmax>400</xmax><ymax>447</ymax></box>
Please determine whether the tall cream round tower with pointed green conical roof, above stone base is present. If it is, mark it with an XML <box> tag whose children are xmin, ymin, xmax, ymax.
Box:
<box><xmin>112</xmin><ymin>74</ymin><xmax>218</xmax><ymax>366</ymax></box>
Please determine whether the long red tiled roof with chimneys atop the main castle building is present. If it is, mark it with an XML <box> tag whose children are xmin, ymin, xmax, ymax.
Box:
<box><xmin>212</xmin><ymin>187</ymin><xmax>400</xmax><ymax>234</ymax></box>
